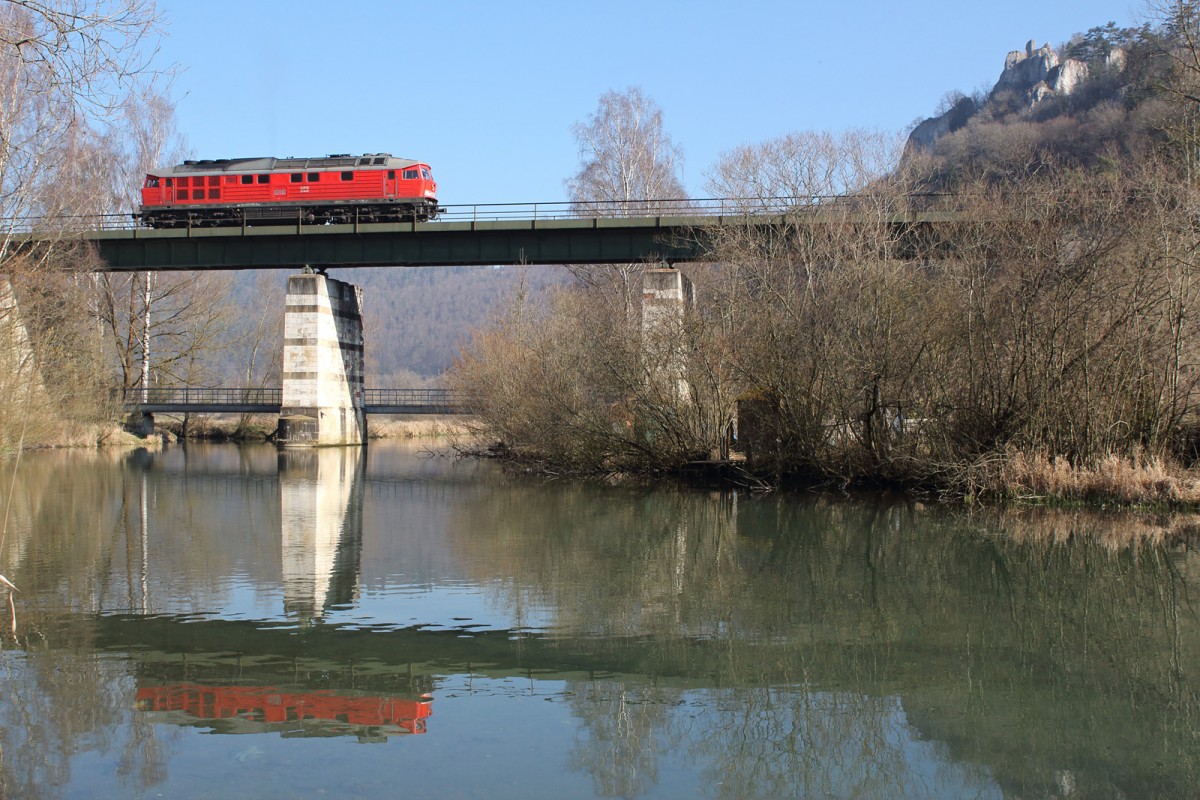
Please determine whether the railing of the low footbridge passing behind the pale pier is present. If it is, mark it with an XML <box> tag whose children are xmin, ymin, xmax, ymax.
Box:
<box><xmin>119</xmin><ymin>386</ymin><xmax>466</xmax><ymax>414</ymax></box>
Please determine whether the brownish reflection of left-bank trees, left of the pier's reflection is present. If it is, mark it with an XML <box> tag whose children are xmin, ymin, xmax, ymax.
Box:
<box><xmin>0</xmin><ymin>445</ymin><xmax>280</xmax><ymax>613</ymax></box>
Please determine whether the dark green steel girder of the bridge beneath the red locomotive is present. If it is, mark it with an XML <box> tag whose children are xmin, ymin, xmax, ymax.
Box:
<box><xmin>82</xmin><ymin>216</ymin><xmax>729</xmax><ymax>272</ymax></box>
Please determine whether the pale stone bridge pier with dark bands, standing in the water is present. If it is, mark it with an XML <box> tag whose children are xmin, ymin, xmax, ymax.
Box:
<box><xmin>277</xmin><ymin>272</ymin><xmax>367</xmax><ymax>447</ymax></box>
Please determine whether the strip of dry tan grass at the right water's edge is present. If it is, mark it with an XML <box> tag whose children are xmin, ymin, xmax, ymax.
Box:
<box><xmin>979</xmin><ymin>452</ymin><xmax>1200</xmax><ymax>506</ymax></box>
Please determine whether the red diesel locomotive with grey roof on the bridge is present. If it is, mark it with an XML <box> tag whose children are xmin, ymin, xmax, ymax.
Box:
<box><xmin>133</xmin><ymin>152</ymin><xmax>438</xmax><ymax>228</ymax></box>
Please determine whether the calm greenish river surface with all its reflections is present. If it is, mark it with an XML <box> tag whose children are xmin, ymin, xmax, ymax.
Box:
<box><xmin>0</xmin><ymin>444</ymin><xmax>1200</xmax><ymax>799</ymax></box>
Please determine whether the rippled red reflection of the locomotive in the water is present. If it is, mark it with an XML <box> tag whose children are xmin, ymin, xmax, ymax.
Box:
<box><xmin>137</xmin><ymin>684</ymin><xmax>433</xmax><ymax>734</ymax></box>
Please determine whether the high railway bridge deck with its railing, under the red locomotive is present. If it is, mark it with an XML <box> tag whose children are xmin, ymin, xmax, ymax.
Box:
<box><xmin>5</xmin><ymin>194</ymin><xmax>962</xmax><ymax>272</ymax></box>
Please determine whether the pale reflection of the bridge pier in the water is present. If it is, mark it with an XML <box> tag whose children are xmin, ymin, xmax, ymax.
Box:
<box><xmin>278</xmin><ymin>447</ymin><xmax>365</xmax><ymax>619</ymax></box>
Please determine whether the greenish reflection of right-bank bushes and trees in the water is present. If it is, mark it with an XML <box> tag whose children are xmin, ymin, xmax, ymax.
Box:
<box><xmin>450</xmin><ymin>487</ymin><xmax>1200</xmax><ymax>796</ymax></box>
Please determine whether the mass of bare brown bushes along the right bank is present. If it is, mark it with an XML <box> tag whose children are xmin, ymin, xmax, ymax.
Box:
<box><xmin>454</xmin><ymin>164</ymin><xmax>1200</xmax><ymax>504</ymax></box>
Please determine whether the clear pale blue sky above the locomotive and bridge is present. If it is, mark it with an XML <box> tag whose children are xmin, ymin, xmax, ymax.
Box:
<box><xmin>158</xmin><ymin>0</ymin><xmax>1144</xmax><ymax>204</ymax></box>
